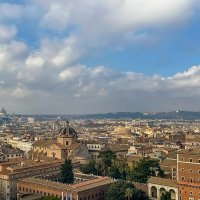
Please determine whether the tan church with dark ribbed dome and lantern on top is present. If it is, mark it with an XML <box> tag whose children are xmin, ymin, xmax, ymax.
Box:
<box><xmin>28</xmin><ymin>121</ymin><xmax>91</xmax><ymax>165</ymax></box>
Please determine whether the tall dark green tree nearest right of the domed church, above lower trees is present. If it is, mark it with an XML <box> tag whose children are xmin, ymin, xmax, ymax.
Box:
<box><xmin>97</xmin><ymin>149</ymin><xmax>117</xmax><ymax>176</ymax></box>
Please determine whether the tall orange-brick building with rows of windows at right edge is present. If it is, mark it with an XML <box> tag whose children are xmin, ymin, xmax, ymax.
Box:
<box><xmin>177</xmin><ymin>149</ymin><xmax>200</xmax><ymax>200</ymax></box>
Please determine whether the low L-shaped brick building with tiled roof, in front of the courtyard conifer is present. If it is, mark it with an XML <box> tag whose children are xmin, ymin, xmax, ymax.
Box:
<box><xmin>17</xmin><ymin>175</ymin><xmax>114</xmax><ymax>200</ymax></box>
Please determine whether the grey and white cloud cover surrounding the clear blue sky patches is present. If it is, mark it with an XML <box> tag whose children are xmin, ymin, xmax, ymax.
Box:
<box><xmin>0</xmin><ymin>0</ymin><xmax>200</xmax><ymax>113</ymax></box>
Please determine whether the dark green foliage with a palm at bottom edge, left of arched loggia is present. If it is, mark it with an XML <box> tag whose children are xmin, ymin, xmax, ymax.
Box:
<box><xmin>105</xmin><ymin>180</ymin><xmax>149</xmax><ymax>200</ymax></box>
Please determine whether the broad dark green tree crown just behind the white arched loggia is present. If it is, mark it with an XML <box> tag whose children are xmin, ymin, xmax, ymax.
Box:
<box><xmin>128</xmin><ymin>158</ymin><xmax>164</xmax><ymax>183</ymax></box>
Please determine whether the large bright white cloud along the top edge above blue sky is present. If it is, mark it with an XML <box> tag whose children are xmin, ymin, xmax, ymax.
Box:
<box><xmin>34</xmin><ymin>0</ymin><xmax>199</xmax><ymax>45</ymax></box>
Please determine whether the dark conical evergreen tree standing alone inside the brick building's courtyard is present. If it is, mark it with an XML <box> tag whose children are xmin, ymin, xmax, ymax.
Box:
<box><xmin>61</xmin><ymin>159</ymin><xmax>74</xmax><ymax>184</ymax></box>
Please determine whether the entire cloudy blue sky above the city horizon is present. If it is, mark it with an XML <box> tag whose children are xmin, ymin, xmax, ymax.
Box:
<box><xmin>0</xmin><ymin>0</ymin><xmax>200</xmax><ymax>114</ymax></box>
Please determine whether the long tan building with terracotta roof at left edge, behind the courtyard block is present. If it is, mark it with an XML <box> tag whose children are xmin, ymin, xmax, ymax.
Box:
<box><xmin>0</xmin><ymin>158</ymin><xmax>76</xmax><ymax>200</ymax></box>
